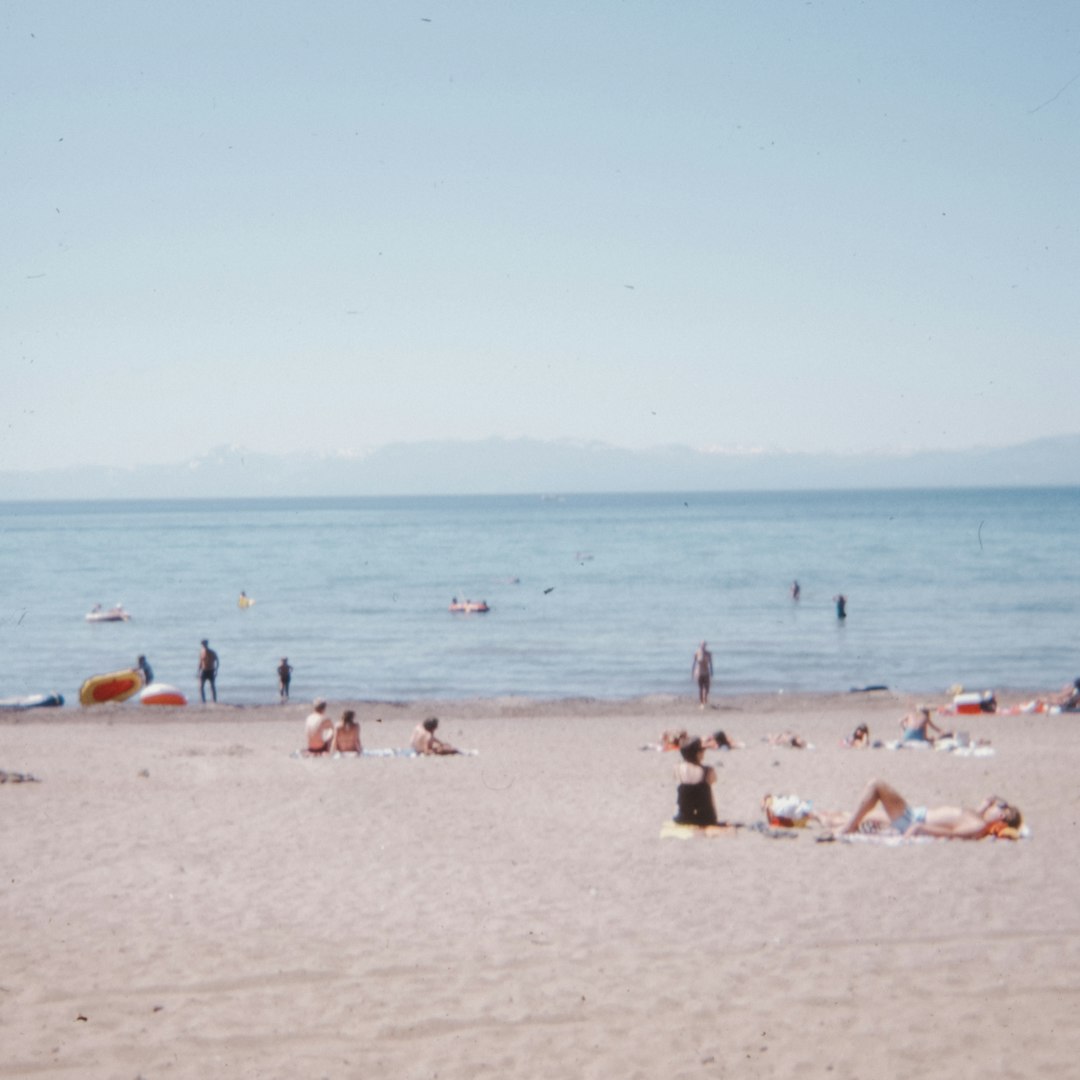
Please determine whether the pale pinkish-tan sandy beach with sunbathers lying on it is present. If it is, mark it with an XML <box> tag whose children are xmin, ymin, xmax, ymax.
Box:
<box><xmin>0</xmin><ymin>692</ymin><xmax>1080</xmax><ymax>1080</ymax></box>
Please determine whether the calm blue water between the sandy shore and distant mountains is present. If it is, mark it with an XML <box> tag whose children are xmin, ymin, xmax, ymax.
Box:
<box><xmin>0</xmin><ymin>488</ymin><xmax>1080</xmax><ymax>707</ymax></box>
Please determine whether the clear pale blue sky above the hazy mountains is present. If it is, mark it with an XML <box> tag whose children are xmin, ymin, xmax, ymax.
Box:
<box><xmin>0</xmin><ymin>0</ymin><xmax>1080</xmax><ymax>470</ymax></box>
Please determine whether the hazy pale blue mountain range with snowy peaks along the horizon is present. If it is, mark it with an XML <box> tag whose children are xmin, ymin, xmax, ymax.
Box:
<box><xmin>0</xmin><ymin>434</ymin><xmax>1080</xmax><ymax>500</ymax></box>
